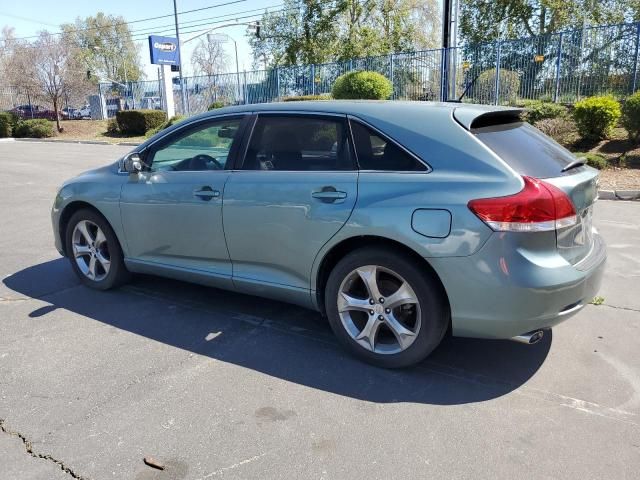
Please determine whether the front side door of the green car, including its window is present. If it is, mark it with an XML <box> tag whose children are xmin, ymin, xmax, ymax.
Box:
<box><xmin>120</xmin><ymin>117</ymin><xmax>242</xmax><ymax>279</ymax></box>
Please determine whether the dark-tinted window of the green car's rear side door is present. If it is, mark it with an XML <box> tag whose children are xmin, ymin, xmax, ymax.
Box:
<box><xmin>242</xmin><ymin>115</ymin><xmax>354</xmax><ymax>171</ymax></box>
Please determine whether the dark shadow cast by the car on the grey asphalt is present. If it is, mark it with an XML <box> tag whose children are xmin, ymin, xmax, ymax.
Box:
<box><xmin>3</xmin><ymin>259</ymin><xmax>552</xmax><ymax>405</ymax></box>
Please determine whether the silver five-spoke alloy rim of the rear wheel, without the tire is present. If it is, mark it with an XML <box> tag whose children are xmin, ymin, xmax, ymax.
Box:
<box><xmin>337</xmin><ymin>265</ymin><xmax>421</xmax><ymax>354</ymax></box>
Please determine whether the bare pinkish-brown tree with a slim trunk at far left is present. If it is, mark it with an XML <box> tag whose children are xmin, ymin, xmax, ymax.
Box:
<box><xmin>10</xmin><ymin>31</ymin><xmax>90</xmax><ymax>131</ymax></box>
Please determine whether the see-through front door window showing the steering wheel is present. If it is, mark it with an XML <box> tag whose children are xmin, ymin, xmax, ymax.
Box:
<box><xmin>151</xmin><ymin>118</ymin><xmax>242</xmax><ymax>172</ymax></box>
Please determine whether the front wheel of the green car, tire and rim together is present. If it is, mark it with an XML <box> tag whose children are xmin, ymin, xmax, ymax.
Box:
<box><xmin>65</xmin><ymin>209</ymin><xmax>130</xmax><ymax>290</ymax></box>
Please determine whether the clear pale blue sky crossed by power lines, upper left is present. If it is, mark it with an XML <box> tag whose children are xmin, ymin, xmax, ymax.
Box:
<box><xmin>0</xmin><ymin>0</ymin><xmax>283</xmax><ymax>79</ymax></box>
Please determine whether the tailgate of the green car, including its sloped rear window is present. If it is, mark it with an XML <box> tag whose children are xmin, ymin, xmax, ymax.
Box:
<box><xmin>472</xmin><ymin>121</ymin><xmax>598</xmax><ymax>265</ymax></box>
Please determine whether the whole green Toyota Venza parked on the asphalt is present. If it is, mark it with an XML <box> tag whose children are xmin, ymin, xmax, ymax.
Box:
<box><xmin>52</xmin><ymin>101</ymin><xmax>606</xmax><ymax>367</ymax></box>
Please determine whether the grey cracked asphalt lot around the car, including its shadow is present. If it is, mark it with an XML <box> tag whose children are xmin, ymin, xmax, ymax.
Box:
<box><xmin>0</xmin><ymin>142</ymin><xmax>640</xmax><ymax>480</ymax></box>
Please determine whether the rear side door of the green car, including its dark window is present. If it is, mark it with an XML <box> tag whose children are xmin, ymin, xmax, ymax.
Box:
<box><xmin>223</xmin><ymin>113</ymin><xmax>358</xmax><ymax>293</ymax></box>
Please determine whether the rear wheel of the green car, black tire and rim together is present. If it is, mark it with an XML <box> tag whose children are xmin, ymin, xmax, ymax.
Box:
<box><xmin>325</xmin><ymin>247</ymin><xmax>449</xmax><ymax>368</ymax></box>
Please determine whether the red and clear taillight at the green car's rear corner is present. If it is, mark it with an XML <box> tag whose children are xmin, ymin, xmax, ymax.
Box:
<box><xmin>468</xmin><ymin>176</ymin><xmax>577</xmax><ymax>232</ymax></box>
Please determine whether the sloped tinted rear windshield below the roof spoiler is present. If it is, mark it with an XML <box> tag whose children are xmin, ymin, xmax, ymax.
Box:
<box><xmin>472</xmin><ymin>122</ymin><xmax>578</xmax><ymax>178</ymax></box>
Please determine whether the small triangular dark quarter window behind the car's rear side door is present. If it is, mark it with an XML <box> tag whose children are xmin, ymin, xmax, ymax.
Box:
<box><xmin>351</xmin><ymin>121</ymin><xmax>427</xmax><ymax>172</ymax></box>
